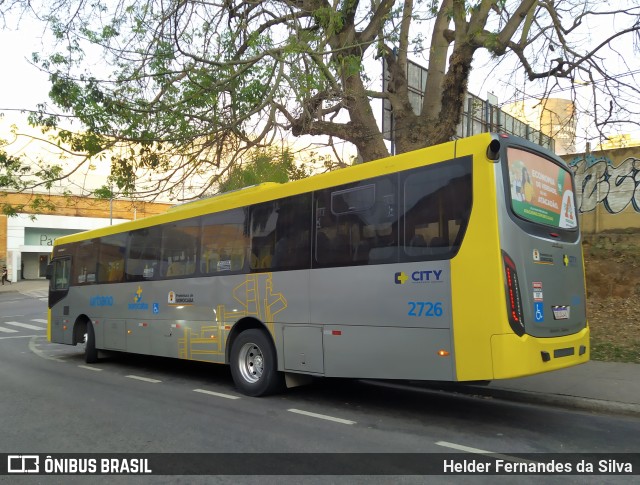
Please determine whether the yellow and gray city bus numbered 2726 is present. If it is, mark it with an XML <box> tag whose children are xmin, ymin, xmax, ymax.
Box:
<box><xmin>48</xmin><ymin>134</ymin><xmax>589</xmax><ymax>396</ymax></box>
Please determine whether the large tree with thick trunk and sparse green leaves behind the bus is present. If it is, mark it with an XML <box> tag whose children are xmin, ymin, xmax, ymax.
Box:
<box><xmin>1</xmin><ymin>0</ymin><xmax>640</xmax><ymax>199</ymax></box>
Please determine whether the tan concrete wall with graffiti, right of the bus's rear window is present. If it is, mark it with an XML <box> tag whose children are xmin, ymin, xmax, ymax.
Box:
<box><xmin>562</xmin><ymin>147</ymin><xmax>640</xmax><ymax>234</ymax></box>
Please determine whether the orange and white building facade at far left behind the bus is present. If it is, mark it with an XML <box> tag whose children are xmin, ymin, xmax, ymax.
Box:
<box><xmin>0</xmin><ymin>193</ymin><xmax>170</xmax><ymax>281</ymax></box>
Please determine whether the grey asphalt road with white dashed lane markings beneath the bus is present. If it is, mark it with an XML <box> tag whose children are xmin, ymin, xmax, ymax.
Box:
<box><xmin>0</xmin><ymin>294</ymin><xmax>640</xmax><ymax>483</ymax></box>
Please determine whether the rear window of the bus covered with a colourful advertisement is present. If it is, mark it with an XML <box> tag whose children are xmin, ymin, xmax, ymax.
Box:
<box><xmin>507</xmin><ymin>148</ymin><xmax>577</xmax><ymax>229</ymax></box>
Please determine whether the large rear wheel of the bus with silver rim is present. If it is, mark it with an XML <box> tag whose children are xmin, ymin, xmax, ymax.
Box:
<box><xmin>230</xmin><ymin>328</ymin><xmax>284</xmax><ymax>397</ymax></box>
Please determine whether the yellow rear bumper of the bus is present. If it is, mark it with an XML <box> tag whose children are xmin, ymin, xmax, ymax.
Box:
<box><xmin>491</xmin><ymin>326</ymin><xmax>590</xmax><ymax>379</ymax></box>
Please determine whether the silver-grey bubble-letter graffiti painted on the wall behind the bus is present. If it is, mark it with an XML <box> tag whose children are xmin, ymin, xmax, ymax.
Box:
<box><xmin>569</xmin><ymin>154</ymin><xmax>640</xmax><ymax>214</ymax></box>
